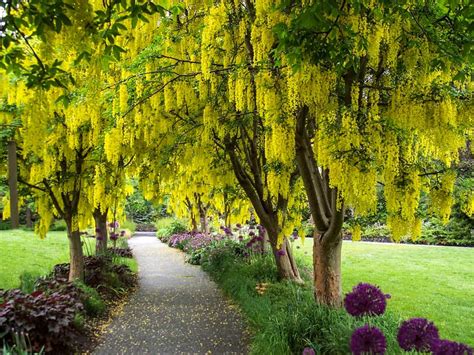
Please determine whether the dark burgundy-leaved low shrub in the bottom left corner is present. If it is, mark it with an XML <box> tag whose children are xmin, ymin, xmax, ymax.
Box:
<box><xmin>0</xmin><ymin>289</ymin><xmax>83</xmax><ymax>352</ymax></box>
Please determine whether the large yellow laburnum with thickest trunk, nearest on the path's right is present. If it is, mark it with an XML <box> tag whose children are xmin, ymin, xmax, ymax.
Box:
<box><xmin>266</xmin><ymin>1</ymin><xmax>473</xmax><ymax>306</ymax></box>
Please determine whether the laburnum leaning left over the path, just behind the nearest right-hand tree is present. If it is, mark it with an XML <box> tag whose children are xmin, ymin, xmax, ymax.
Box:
<box><xmin>110</xmin><ymin>3</ymin><xmax>312</xmax><ymax>280</ymax></box>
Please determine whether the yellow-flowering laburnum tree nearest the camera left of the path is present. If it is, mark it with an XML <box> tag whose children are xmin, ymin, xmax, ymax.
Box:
<box><xmin>2</xmin><ymin>1</ymin><xmax>141</xmax><ymax>280</ymax></box>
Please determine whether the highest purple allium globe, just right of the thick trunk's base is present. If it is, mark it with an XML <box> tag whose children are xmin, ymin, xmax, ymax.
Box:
<box><xmin>344</xmin><ymin>283</ymin><xmax>388</xmax><ymax>317</ymax></box>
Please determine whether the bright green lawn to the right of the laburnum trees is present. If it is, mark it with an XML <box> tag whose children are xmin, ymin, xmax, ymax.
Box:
<box><xmin>296</xmin><ymin>239</ymin><xmax>474</xmax><ymax>346</ymax></box>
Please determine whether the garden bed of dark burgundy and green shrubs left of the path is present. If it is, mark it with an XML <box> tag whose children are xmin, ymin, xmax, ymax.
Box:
<box><xmin>0</xmin><ymin>256</ymin><xmax>137</xmax><ymax>354</ymax></box>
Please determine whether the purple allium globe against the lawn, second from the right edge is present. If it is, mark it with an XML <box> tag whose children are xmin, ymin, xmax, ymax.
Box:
<box><xmin>397</xmin><ymin>318</ymin><xmax>439</xmax><ymax>352</ymax></box>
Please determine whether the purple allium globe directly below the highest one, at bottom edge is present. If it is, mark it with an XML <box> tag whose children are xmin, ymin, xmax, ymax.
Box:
<box><xmin>351</xmin><ymin>324</ymin><xmax>387</xmax><ymax>355</ymax></box>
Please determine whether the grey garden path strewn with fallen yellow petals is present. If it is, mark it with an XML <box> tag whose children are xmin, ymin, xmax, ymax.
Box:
<box><xmin>94</xmin><ymin>233</ymin><xmax>248</xmax><ymax>354</ymax></box>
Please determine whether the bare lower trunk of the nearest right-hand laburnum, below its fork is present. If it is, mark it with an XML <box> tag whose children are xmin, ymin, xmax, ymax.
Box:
<box><xmin>313</xmin><ymin>232</ymin><xmax>342</xmax><ymax>307</ymax></box>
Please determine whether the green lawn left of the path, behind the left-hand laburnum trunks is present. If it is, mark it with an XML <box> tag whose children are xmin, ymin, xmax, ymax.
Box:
<box><xmin>0</xmin><ymin>230</ymin><xmax>137</xmax><ymax>289</ymax></box>
